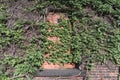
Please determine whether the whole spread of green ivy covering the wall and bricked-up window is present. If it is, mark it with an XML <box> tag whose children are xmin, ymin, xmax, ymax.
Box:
<box><xmin>0</xmin><ymin>0</ymin><xmax>120</xmax><ymax>80</ymax></box>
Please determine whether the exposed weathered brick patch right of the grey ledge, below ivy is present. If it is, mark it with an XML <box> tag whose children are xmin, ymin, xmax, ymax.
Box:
<box><xmin>87</xmin><ymin>63</ymin><xmax>119</xmax><ymax>80</ymax></box>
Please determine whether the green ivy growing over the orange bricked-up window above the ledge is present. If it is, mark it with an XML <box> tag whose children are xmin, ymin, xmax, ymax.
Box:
<box><xmin>40</xmin><ymin>21</ymin><xmax>72</xmax><ymax>63</ymax></box>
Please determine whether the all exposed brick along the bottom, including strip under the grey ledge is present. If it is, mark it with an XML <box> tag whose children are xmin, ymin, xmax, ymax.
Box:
<box><xmin>33</xmin><ymin>62</ymin><xmax>119</xmax><ymax>80</ymax></box>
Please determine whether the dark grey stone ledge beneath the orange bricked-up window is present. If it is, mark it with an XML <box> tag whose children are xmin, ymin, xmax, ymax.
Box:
<box><xmin>35</xmin><ymin>69</ymin><xmax>81</xmax><ymax>77</ymax></box>
